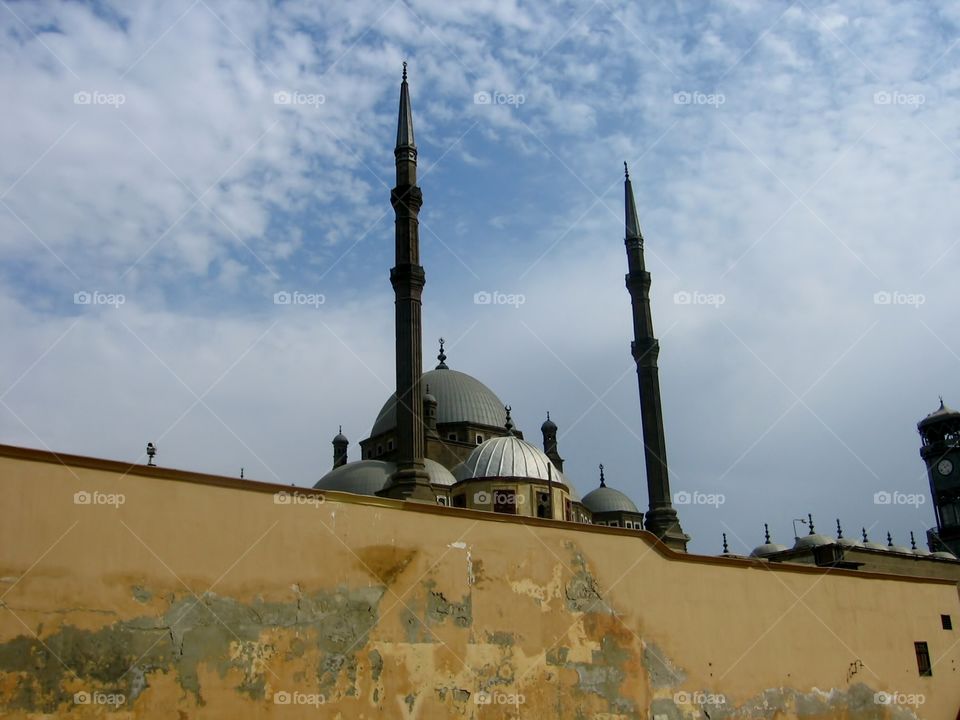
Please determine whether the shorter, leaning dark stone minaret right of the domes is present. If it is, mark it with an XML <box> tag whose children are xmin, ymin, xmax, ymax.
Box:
<box><xmin>623</xmin><ymin>163</ymin><xmax>690</xmax><ymax>550</ymax></box>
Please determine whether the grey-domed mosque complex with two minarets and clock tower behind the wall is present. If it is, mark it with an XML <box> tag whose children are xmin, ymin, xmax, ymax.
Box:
<box><xmin>314</xmin><ymin>64</ymin><xmax>960</xmax><ymax>577</ymax></box>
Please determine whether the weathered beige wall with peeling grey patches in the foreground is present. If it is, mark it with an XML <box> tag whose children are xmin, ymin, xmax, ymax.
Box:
<box><xmin>0</xmin><ymin>448</ymin><xmax>960</xmax><ymax>720</ymax></box>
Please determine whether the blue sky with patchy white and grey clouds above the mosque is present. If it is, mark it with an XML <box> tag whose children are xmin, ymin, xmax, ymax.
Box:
<box><xmin>0</xmin><ymin>0</ymin><xmax>960</xmax><ymax>554</ymax></box>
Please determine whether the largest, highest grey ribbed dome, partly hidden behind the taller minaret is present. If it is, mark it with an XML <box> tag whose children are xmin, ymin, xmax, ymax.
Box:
<box><xmin>370</xmin><ymin>368</ymin><xmax>507</xmax><ymax>437</ymax></box>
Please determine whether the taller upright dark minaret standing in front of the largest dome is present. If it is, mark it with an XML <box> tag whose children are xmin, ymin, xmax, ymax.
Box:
<box><xmin>382</xmin><ymin>63</ymin><xmax>435</xmax><ymax>502</ymax></box>
